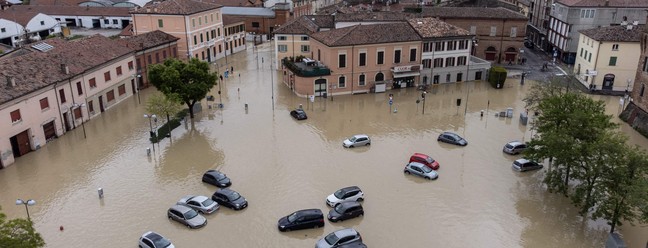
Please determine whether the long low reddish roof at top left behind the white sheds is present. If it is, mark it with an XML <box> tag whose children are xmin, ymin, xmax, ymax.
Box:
<box><xmin>5</xmin><ymin>5</ymin><xmax>130</xmax><ymax>17</ymax></box>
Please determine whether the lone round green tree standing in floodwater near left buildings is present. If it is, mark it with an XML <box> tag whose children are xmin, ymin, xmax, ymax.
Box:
<box><xmin>149</xmin><ymin>58</ymin><xmax>216</xmax><ymax>119</ymax></box>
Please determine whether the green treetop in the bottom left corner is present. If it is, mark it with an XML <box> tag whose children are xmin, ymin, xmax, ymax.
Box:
<box><xmin>0</xmin><ymin>208</ymin><xmax>45</xmax><ymax>248</ymax></box>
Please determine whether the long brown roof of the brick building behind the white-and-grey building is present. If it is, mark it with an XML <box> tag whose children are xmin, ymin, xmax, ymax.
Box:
<box><xmin>422</xmin><ymin>7</ymin><xmax>528</xmax><ymax>20</ymax></box>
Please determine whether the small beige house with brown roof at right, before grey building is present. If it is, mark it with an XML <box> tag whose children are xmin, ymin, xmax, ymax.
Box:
<box><xmin>573</xmin><ymin>25</ymin><xmax>641</xmax><ymax>92</ymax></box>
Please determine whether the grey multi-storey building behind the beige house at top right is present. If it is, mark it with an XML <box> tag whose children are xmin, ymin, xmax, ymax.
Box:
<box><xmin>547</xmin><ymin>0</ymin><xmax>648</xmax><ymax>64</ymax></box>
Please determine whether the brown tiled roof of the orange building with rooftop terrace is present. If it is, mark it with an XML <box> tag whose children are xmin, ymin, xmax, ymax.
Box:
<box><xmin>311</xmin><ymin>22</ymin><xmax>421</xmax><ymax>46</ymax></box>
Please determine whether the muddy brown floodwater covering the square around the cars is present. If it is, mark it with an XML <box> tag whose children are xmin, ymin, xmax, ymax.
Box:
<box><xmin>0</xmin><ymin>44</ymin><xmax>648</xmax><ymax>248</ymax></box>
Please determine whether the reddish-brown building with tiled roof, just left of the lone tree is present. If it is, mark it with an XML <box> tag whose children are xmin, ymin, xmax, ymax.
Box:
<box><xmin>119</xmin><ymin>30</ymin><xmax>180</xmax><ymax>89</ymax></box>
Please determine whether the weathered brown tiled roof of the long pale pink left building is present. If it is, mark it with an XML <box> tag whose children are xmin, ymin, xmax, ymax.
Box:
<box><xmin>0</xmin><ymin>35</ymin><xmax>131</xmax><ymax>104</ymax></box>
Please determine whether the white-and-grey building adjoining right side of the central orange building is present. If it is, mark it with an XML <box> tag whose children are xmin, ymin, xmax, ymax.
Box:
<box><xmin>408</xmin><ymin>17</ymin><xmax>490</xmax><ymax>85</ymax></box>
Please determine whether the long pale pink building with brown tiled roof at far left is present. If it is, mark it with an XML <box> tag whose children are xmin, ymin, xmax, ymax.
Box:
<box><xmin>0</xmin><ymin>35</ymin><xmax>136</xmax><ymax>167</ymax></box>
